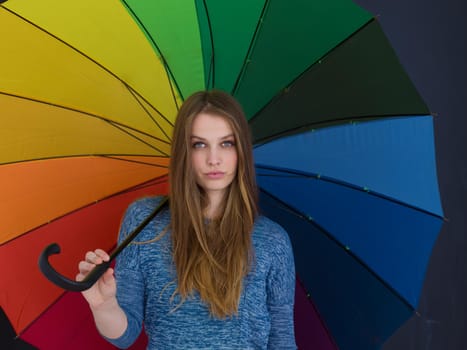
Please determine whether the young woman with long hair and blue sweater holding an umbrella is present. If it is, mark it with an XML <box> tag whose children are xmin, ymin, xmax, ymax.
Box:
<box><xmin>76</xmin><ymin>90</ymin><xmax>296</xmax><ymax>349</ymax></box>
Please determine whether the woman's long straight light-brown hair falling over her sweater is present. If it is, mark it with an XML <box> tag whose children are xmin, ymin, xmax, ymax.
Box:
<box><xmin>169</xmin><ymin>90</ymin><xmax>258</xmax><ymax>318</ymax></box>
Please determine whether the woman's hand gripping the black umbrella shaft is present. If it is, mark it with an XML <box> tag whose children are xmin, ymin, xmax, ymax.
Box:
<box><xmin>76</xmin><ymin>249</ymin><xmax>117</xmax><ymax>309</ymax></box>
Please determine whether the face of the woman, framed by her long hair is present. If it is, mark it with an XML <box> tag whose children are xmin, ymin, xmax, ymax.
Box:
<box><xmin>191</xmin><ymin>113</ymin><xmax>238</xmax><ymax>204</ymax></box>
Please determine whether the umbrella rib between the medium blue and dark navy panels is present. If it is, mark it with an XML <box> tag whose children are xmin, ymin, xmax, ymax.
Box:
<box><xmin>260</xmin><ymin>188</ymin><xmax>414</xmax><ymax>310</ymax></box>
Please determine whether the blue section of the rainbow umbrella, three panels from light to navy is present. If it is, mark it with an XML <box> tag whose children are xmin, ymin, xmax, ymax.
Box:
<box><xmin>255</xmin><ymin>116</ymin><xmax>443</xmax><ymax>349</ymax></box>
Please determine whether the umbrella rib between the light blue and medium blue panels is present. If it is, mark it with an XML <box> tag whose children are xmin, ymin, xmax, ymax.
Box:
<box><xmin>256</xmin><ymin>164</ymin><xmax>445</xmax><ymax>221</ymax></box>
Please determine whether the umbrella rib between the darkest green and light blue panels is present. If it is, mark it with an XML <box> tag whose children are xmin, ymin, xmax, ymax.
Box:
<box><xmin>254</xmin><ymin>113</ymin><xmax>434</xmax><ymax>148</ymax></box>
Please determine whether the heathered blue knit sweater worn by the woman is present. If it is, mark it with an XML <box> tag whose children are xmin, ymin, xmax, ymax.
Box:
<box><xmin>107</xmin><ymin>197</ymin><xmax>296</xmax><ymax>350</ymax></box>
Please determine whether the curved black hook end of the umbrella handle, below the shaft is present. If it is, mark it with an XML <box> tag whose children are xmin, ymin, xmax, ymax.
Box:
<box><xmin>39</xmin><ymin>243</ymin><xmax>111</xmax><ymax>292</ymax></box>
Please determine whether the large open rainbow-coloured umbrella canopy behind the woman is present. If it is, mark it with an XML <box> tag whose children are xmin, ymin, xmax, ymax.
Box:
<box><xmin>0</xmin><ymin>0</ymin><xmax>443</xmax><ymax>349</ymax></box>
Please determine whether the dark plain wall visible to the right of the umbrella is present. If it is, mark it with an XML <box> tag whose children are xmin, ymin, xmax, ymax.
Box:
<box><xmin>356</xmin><ymin>0</ymin><xmax>467</xmax><ymax>350</ymax></box>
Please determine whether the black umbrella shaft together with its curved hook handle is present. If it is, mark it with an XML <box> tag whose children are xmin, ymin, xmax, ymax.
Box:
<box><xmin>39</xmin><ymin>197</ymin><xmax>168</xmax><ymax>292</ymax></box>
